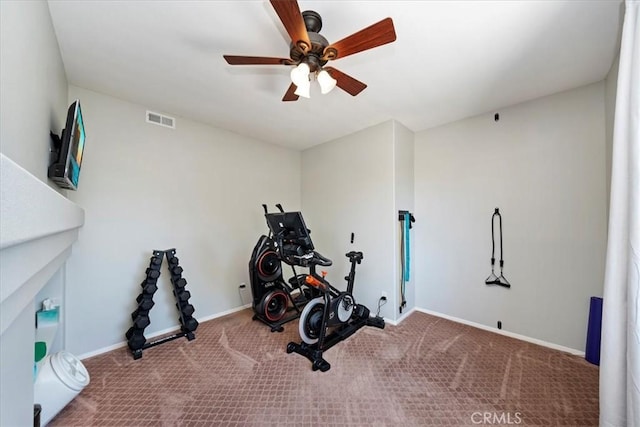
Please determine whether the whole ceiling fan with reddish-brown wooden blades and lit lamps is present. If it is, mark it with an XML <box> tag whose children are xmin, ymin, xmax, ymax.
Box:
<box><xmin>223</xmin><ymin>0</ymin><xmax>396</xmax><ymax>101</ymax></box>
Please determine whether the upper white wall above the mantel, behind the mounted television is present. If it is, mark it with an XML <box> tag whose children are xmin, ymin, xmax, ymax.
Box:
<box><xmin>0</xmin><ymin>0</ymin><xmax>68</xmax><ymax>182</ymax></box>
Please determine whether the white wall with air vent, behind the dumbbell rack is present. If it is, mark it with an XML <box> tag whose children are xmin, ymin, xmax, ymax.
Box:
<box><xmin>66</xmin><ymin>86</ymin><xmax>300</xmax><ymax>355</ymax></box>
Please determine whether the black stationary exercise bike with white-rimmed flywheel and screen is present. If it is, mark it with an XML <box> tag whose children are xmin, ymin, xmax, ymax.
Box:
<box><xmin>267</xmin><ymin>217</ymin><xmax>384</xmax><ymax>372</ymax></box>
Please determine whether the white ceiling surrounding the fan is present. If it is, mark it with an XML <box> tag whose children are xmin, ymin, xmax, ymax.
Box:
<box><xmin>49</xmin><ymin>0</ymin><xmax>622</xmax><ymax>149</ymax></box>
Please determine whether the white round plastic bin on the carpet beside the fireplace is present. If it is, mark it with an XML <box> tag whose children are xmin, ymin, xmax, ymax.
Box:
<box><xmin>33</xmin><ymin>351</ymin><xmax>89</xmax><ymax>426</ymax></box>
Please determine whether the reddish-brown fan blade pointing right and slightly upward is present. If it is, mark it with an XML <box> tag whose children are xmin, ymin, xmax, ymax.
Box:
<box><xmin>323</xmin><ymin>18</ymin><xmax>396</xmax><ymax>59</ymax></box>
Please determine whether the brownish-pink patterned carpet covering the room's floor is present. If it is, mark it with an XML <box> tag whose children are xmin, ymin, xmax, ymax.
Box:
<box><xmin>50</xmin><ymin>310</ymin><xmax>598</xmax><ymax>426</ymax></box>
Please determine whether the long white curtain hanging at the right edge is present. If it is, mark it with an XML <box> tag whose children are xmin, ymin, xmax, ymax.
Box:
<box><xmin>600</xmin><ymin>0</ymin><xmax>640</xmax><ymax>427</ymax></box>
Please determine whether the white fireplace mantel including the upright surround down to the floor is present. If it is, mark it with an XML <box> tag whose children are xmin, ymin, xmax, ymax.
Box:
<box><xmin>0</xmin><ymin>153</ymin><xmax>84</xmax><ymax>425</ymax></box>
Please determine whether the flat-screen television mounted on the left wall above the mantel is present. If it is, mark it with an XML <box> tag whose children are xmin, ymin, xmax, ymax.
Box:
<box><xmin>48</xmin><ymin>99</ymin><xmax>86</xmax><ymax>190</ymax></box>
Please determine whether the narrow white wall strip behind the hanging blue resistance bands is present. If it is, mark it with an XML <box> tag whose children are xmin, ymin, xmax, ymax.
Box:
<box><xmin>390</xmin><ymin>121</ymin><xmax>415</xmax><ymax>317</ymax></box>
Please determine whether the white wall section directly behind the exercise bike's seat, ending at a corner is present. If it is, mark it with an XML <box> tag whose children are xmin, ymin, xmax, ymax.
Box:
<box><xmin>302</xmin><ymin>121</ymin><xmax>397</xmax><ymax>318</ymax></box>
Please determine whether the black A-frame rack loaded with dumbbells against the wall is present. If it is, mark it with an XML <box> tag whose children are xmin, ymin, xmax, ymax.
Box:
<box><xmin>125</xmin><ymin>249</ymin><xmax>198</xmax><ymax>359</ymax></box>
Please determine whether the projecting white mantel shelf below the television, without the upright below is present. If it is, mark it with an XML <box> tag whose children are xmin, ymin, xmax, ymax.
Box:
<box><xmin>0</xmin><ymin>153</ymin><xmax>84</xmax><ymax>334</ymax></box>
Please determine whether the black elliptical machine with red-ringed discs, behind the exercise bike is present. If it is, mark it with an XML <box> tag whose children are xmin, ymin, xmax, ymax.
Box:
<box><xmin>249</xmin><ymin>204</ymin><xmax>320</xmax><ymax>332</ymax></box>
